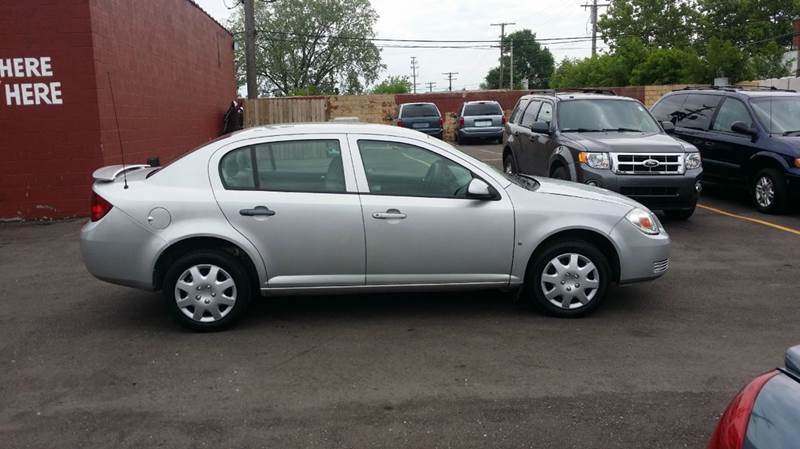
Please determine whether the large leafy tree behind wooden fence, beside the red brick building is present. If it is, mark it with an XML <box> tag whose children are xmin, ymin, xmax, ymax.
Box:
<box><xmin>230</xmin><ymin>0</ymin><xmax>384</xmax><ymax>96</ymax></box>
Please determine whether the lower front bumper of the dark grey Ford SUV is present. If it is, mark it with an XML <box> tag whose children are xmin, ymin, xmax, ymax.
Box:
<box><xmin>576</xmin><ymin>164</ymin><xmax>703</xmax><ymax>210</ymax></box>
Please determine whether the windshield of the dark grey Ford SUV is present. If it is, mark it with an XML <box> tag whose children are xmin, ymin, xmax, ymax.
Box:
<box><xmin>558</xmin><ymin>99</ymin><xmax>660</xmax><ymax>133</ymax></box>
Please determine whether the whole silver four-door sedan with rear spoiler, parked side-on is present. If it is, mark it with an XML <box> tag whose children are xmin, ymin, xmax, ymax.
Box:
<box><xmin>81</xmin><ymin>123</ymin><xmax>670</xmax><ymax>330</ymax></box>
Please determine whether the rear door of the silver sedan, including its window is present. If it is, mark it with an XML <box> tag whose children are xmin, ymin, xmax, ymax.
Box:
<box><xmin>209</xmin><ymin>135</ymin><xmax>365</xmax><ymax>288</ymax></box>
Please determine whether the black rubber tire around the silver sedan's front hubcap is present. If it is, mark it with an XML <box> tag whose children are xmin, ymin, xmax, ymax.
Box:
<box><xmin>524</xmin><ymin>240</ymin><xmax>611</xmax><ymax>318</ymax></box>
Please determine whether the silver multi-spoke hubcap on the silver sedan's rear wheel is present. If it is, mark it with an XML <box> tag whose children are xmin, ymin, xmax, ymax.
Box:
<box><xmin>175</xmin><ymin>264</ymin><xmax>236</xmax><ymax>323</ymax></box>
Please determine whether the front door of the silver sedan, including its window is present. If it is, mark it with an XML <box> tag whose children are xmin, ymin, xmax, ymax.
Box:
<box><xmin>350</xmin><ymin>135</ymin><xmax>514</xmax><ymax>285</ymax></box>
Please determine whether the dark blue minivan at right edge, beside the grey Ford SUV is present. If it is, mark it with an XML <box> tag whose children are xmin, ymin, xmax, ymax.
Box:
<box><xmin>652</xmin><ymin>87</ymin><xmax>800</xmax><ymax>213</ymax></box>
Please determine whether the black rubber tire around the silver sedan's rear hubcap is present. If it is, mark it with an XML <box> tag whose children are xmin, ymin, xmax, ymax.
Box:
<box><xmin>163</xmin><ymin>250</ymin><xmax>254</xmax><ymax>332</ymax></box>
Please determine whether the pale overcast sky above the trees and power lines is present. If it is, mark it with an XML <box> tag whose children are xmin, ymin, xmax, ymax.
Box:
<box><xmin>195</xmin><ymin>0</ymin><xmax>602</xmax><ymax>91</ymax></box>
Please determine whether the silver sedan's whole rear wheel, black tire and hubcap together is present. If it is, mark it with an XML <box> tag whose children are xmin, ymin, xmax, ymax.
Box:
<box><xmin>163</xmin><ymin>250</ymin><xmax>252</xmax><ymax>331</ymax></box>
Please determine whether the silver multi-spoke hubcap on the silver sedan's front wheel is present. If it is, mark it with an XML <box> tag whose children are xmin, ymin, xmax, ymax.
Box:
<box><xmin>541</xmin><ymin>253</ymin><xmax>600</xmax><ymax>309</ymax></box>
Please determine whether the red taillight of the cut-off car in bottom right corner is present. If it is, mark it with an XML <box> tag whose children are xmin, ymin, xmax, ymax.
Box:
<box><xmin>708</xmin><ymin>371</ymin><xmax>778</xmax><ymax>449</ymax></box>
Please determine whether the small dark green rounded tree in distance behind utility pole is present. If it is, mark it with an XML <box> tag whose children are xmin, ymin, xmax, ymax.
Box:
<box><xmin>481</xmin><ymin>29</ymin><xmax>554</xmax><ymax>89</ymax></box>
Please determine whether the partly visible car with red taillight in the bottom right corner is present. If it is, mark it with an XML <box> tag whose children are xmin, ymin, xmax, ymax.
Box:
<box><xmin>708</xmin><ymin>346</ymin><xmax>800</xmax><ymax>449</ymax></box>
